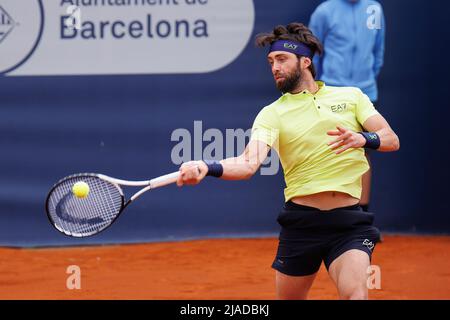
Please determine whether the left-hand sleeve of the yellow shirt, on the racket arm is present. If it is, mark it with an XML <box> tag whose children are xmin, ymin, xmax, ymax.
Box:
<box><xmin>250</xmin><ymin>107</ymin><xmax>280</xmax><ymax>147</ymax></box>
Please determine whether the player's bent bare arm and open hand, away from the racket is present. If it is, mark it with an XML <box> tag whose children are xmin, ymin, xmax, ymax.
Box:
<box><xmin>327</xmin><ymin>114</ymin><xmax>400</xmax><ymax>154</ymax></box>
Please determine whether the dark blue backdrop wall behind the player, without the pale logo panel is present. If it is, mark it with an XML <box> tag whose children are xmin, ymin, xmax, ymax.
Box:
<box><xmin>0</xmin><ymin>0</ymin><xmax>450</xmax><ymax>246</ymax></box>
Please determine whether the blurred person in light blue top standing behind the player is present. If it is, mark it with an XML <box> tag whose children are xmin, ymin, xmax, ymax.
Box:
<box><xmin>309</xmin><ymin>0</ymin><xmax>385</xmax><ymax>211</ymax></box>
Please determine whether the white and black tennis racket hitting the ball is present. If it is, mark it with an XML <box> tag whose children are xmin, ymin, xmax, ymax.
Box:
<box><xmin>45</xmin><ymin>172</ymin><xmax>179</xmax><ymax>237</ymax></box>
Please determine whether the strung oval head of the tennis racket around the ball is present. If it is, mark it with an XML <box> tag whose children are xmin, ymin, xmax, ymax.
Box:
<box><xmin>47</xmin><ymin>175</ymin><xmax>123</xmax><ymax>237</ymax></box>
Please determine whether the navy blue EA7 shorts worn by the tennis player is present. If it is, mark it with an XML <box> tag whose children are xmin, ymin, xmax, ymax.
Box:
<box><xmin>272</xmin><ymin>201</ymin><xmax>380</xmax><ymax>276</ymax></box>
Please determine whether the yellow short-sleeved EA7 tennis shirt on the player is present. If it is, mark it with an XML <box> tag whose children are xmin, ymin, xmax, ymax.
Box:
<box><xmin>251</xmin><ymin>81</ymin><xmax>378</xmax><ymax>201</ymax></box>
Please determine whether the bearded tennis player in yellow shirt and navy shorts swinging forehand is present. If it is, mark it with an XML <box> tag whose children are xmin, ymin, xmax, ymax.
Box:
<box><xmin>177</xmin><ymin>23</ymin><xmax>400</xmax><ymax>299</ymax></box>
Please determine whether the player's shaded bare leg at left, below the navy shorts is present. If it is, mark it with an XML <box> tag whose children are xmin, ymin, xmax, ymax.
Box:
<box><xmin>275</xmin><ymin>271</ymin><xmax>317</xmax><ymax>300</ymax></box>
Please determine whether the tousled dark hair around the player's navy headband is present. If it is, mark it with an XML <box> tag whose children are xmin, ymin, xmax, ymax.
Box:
<box><xmin>255</xmin><ymin>22</ymin><xmax>323</xmax><ymax>78</ymax></box>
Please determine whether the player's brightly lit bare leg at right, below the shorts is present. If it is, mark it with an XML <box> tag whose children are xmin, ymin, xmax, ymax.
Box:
<box><xmin>328</xmin><ymin>249</ymin><xmax>370</xmax><ymax>299</ymax></box>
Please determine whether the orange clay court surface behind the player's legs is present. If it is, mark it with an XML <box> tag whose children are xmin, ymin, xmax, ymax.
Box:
<box><xmin>0</xmin><ymin>235</ymin><xmax>450</xmax><ymax>300</ymax></box>
